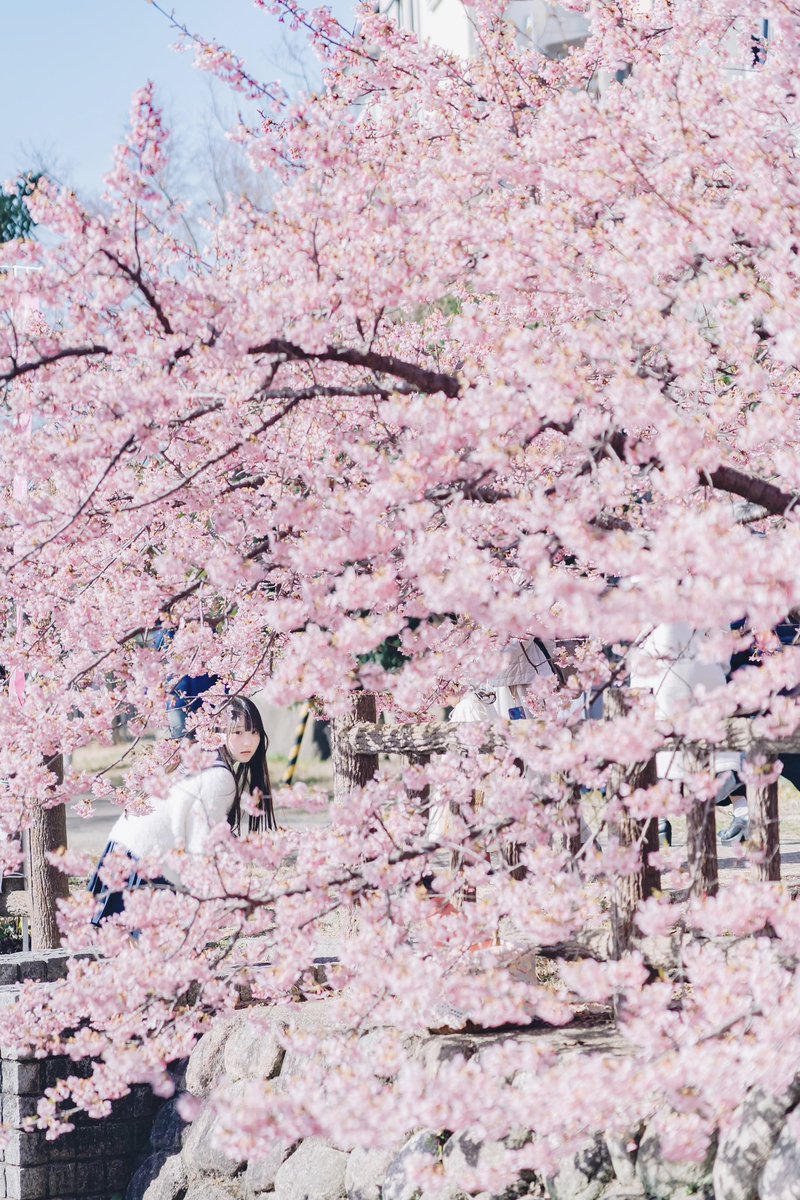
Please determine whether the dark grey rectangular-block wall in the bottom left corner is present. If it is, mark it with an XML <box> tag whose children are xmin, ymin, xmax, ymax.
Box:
<box><xmin>0</xmin><ymin>950</ymin><xmax>161</xmax><ymax>1200</ymax></box>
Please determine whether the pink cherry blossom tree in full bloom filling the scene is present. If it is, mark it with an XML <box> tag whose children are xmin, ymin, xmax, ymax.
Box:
<box><xmin>0</xmin><ymin>0</ymin><xmax>800</xmax><ymax>1182</ymax></box>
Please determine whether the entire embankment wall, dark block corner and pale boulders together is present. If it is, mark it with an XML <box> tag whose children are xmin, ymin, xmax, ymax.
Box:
<box><xmin>0</xmin><ymin>952</ymin><xmax>800</xmax><ymax>1200</ymax></box>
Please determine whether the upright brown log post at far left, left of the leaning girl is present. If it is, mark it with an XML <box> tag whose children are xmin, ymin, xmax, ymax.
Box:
<box><xmin>26</xmin><ymin>755</ymin><xmax>70</xmax><ymax>950</ymax></box>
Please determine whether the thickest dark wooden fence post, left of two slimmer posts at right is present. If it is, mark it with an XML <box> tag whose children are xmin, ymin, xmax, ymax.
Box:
<box><xmin>603</xmin><ymin>688</ymin><xmax>661</xmax><ymax>959</ymax></box>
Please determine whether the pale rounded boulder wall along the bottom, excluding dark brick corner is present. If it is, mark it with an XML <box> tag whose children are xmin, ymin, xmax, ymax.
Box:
<box><xmin>126</xmin><ymin>1002</ymin><xmax>800</xmax><ymax>1200</ymax></box>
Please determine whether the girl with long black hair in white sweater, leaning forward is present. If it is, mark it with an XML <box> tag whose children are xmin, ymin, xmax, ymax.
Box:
<box><xmin>89</xmin><ymin>696</ymin><xmax>277</xmax><ymax>925</ymax></box>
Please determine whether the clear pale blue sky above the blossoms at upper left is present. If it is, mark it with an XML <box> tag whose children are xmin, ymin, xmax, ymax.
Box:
<box><xmin>0</xmin><ymin>0</ymin><xmax>354</xmax><ymax>196</ymax></box>
